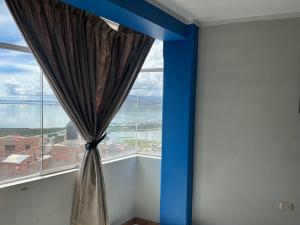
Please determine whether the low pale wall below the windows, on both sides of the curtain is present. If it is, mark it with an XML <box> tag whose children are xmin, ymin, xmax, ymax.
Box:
<box><xmin>0</xmin><ymin>157</ymin><xmax>160</xmax><ymax>225</ymax></box>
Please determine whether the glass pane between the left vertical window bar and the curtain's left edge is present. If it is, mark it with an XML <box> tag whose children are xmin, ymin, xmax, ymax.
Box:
<box><xmin>43</xmin><ymin>77</ymin><xmax>85</xmax><ymax>170</ymax></box>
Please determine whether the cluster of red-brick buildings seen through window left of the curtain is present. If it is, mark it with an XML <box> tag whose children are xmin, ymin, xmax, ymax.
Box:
<box><xmin>0</xmin><ymin>132</ymin><xmax>83</xmax><ymax>180</ymax></box>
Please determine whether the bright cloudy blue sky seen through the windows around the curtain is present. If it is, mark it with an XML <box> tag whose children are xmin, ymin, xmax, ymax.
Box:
<box><xmin>0</xmin><ymin>0</ymin><xmax>163</xmax><ymax>100</ymax></box>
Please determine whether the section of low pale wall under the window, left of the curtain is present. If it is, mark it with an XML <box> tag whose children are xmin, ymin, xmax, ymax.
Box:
<box><xmin>0</xmin><ymin>173</ymin><xmax>76</xmax><ymax>225</ymax></box>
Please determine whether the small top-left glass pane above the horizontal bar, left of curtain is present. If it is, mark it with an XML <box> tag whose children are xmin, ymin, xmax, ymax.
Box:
<box><xmin>0</xmin><ymin>0</ymin><xmax>27</xmax><ymax>46</ymax></box>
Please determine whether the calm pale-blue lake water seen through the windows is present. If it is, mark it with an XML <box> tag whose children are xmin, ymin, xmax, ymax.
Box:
<box><xmin>0</xmin><ymin>101</ymin><xmax>161</xmax><ymax>141</ymax></box>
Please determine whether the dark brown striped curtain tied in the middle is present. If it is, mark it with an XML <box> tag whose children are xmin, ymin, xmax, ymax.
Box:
<box><xmin>6</xmin><ymin>0</ymin><xmax>154</xmax><ymax>225</ymax></box>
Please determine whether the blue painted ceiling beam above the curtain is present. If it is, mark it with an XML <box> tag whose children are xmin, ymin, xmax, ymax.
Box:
<box><xmin>61</xmin><ymin>0</ymin><xmax>187</xmax><ymax>41</ymax></box>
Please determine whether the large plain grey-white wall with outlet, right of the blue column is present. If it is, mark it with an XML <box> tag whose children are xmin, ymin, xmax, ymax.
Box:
<box><xmin>193</xmin><ymin>19</ymin><xmax>300</xmax><ymax>225</ymax></box>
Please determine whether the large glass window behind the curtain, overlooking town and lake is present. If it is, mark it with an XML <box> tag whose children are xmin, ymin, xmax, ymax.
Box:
<box><xmin>0</xmin><ymin>1</ymin><xmax>163</xmax><ymax>183</ymax></box>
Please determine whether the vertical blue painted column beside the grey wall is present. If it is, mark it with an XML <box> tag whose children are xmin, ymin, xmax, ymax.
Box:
<box><xmin>160</xmin><ymin>25</ymin><xmax>198</xmax><ymax>225</ymax></box>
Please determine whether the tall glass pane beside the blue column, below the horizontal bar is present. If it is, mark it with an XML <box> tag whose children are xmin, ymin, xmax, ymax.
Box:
<box><xmin>131</xmin><ymin>72</ymin><xmax>163</xmax><ymax>156</ymax></box>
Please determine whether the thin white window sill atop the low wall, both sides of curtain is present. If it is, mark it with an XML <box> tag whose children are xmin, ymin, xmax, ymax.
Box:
<box><xmin>0</xmin><ymin>154</ymin><xmax>161</xmax><ymax>189</ymax></box>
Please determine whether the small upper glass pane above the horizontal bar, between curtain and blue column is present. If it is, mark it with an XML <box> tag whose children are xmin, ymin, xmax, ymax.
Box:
<box><xmin>143</xmin><ymin>40</ymin><xmax>164</xmax><ymax>68</ymax></box>
